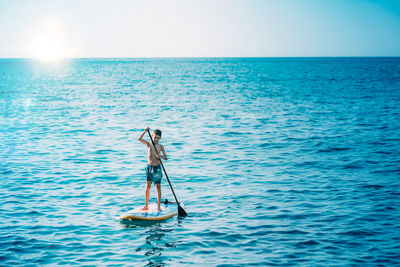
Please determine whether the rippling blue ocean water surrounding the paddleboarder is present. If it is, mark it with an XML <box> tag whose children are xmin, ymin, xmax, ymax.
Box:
<box><xmin>0</xmin><ymin>58</ymin><xmax>400</xmax><ymax>266</ymax></box>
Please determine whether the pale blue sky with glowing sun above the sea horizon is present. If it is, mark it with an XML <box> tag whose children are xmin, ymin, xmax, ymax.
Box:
<box><xmin>0</xmin><ymin>0</ymin><xmax>400</xmax><ymax>59</ymax></box>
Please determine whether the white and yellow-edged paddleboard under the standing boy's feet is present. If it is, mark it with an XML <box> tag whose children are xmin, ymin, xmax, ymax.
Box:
<box><xmin>119</xmin><ymin>203</ymin><xmax>183</xmax><ymax>221</ymax></box>
